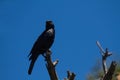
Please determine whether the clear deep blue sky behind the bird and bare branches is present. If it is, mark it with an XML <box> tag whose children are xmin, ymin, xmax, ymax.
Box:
<box><xmin>0</xmin><ymin>0</ymin><xmax>120</xmax><ymax>80</ymax></box>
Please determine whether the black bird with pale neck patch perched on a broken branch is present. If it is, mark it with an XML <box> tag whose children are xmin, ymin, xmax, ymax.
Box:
<box><xmin>28</xmin><ymin>21</ymin><xmax>55</xmax><ymax>75</ymax></box>
